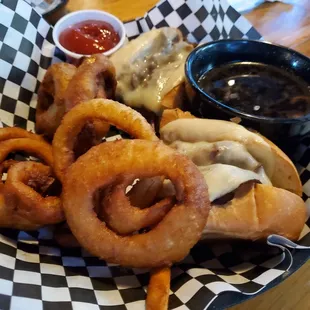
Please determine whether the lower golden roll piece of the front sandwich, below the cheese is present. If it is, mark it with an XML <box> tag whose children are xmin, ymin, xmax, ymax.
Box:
<box><xmin>203</xmin><ymin>184</ymin><xmax>306</xmax><ymax>240</ymax></box>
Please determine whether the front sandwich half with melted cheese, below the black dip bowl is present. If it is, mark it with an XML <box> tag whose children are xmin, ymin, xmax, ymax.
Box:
<box><xmin>160</xmin><ymin>109</ymin><xmax>306</xmax><ymax>240</ymax></box>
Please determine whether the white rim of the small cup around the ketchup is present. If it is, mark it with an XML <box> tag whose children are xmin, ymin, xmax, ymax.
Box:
<box><xmin>53</xmin><ymin>10</ymin><xmax>126</xmax><ymax>59</ymax></box>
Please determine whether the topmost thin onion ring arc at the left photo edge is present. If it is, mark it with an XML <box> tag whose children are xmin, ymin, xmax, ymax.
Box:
<box><xmin>0</xmin><ymin>138</ymin><xmax>53</xmax><ymax>167</ymax></box>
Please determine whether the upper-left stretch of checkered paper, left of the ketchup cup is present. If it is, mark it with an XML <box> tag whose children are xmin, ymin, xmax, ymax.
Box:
<box><xmin>0</xmin><ymin>0</ymin><xmax>63</xmax><ymax>130</ymax></box>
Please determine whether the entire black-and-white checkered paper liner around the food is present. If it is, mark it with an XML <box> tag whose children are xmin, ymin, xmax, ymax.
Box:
<box><xmin>0</xmin><ymin>0</ymin><xmax>310</xmax><ymax>310</ymax></box>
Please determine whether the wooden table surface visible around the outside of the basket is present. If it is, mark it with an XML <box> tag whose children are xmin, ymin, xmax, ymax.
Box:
<box><xmin>49</xmin><ymin>0</ymin><xmax>310</xmax><ymax>310</ymax></box>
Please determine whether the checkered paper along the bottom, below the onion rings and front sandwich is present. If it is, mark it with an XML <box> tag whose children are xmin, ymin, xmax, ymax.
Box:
<box><xmin>0</xmin><ymin>228</ymin><xmax>296</xmax><ymax>310</ymax></box>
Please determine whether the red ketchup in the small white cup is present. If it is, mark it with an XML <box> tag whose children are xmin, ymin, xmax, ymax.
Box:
<box><xmin>59</xmin><ymin>20</ymin><xmax>120</xmax><ymax>55</ymax></box>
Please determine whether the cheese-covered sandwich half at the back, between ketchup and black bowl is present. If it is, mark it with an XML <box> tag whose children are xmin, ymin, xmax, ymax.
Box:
<box><xmin>110</xmin><ymin>27</ymin><xmax>193</xmax><ymax>115</ymax></box>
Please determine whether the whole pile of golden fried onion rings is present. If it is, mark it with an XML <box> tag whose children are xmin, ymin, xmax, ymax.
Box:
<box><xmin>11</xmin><ymin>51</ymin><xmax>210</xmax><ymax>309</ymax></box>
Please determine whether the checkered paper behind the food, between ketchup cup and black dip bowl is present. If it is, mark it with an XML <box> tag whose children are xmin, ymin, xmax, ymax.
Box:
<box><xmin>126</xmin><ymin>0</ymin><xmax>261</xmax><ymax>43</ymax></box>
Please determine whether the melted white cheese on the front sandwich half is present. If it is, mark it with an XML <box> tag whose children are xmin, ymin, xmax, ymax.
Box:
<box><xmin>160</xmin><ymin>119</ymin><xmax>274</xmax><ymax>202</ymax></box>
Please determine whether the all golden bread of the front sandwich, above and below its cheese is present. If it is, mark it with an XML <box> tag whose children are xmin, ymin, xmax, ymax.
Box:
<box><xmin>160</xmin><ymin>109</ymin><xmax>306</xmax><ymax>240</ymax></box>
